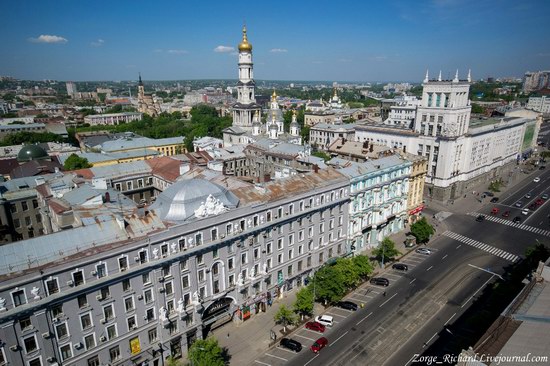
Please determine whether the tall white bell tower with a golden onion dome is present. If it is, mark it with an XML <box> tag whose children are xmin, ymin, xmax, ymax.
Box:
<box><xmin>233</xmin><ymin>26</ymin><xmax>262</xmax><ymax>132</ymax></box>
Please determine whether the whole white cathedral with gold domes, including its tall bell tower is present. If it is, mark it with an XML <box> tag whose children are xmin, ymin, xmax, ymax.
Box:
<box><xmin>223</xmin><ymin>27</ymin><xmax>302</xmax><ymax>146</ymax></box>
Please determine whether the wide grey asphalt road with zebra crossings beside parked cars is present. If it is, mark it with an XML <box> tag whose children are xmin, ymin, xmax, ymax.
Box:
<box><xmin>255</xmin><ymin>164</ymin><xmax>550</xmax><ymax>366</ymax></box>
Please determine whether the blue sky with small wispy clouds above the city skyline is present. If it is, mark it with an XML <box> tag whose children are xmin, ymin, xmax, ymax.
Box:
<box><xmin>0</xmin><ymin>0</ymin><xmax>550</xmax><ymax>81</ymax></box>
